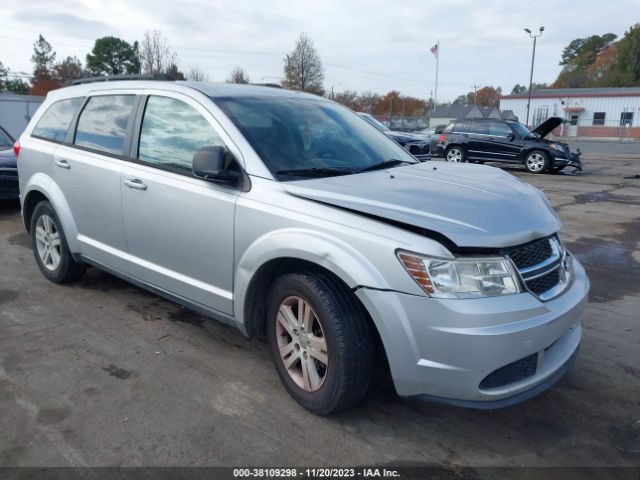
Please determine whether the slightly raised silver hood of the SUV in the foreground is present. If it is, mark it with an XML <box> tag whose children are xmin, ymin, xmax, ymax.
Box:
<box><xmin>283</xmin><ymin>163</ymin><xmax>562</xmax><ymax>249</ymax></box>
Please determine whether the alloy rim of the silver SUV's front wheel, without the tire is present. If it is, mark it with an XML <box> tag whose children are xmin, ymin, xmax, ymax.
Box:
<box><xmin>276</xmin><ymin>296</ymin><xmax>329</xmax><ymax>392</ymax></box>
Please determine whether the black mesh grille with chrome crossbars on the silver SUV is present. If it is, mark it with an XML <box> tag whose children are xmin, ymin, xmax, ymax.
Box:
<box><xmin>506</xmin><ymin>236</ymin><xmax>570</xmax><ymax>301</ymax></box>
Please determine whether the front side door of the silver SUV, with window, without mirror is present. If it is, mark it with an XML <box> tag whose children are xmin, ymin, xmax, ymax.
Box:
<box><xmin>120</xmin><ymin>92</ymin><xmax>240</xmax><ymax>314</ymax></box>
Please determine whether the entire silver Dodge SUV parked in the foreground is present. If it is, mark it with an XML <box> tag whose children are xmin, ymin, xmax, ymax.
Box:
<box><xmin>16</xmin><ymin>80</ymin><xmax>589</xmax><ymax>414</ymax></box>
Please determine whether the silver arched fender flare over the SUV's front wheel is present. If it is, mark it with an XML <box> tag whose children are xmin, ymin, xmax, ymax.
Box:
<box><xmin>234</xmin><ymin>228</ymin><xmax>389</xmax><ymax>325</ymax></box>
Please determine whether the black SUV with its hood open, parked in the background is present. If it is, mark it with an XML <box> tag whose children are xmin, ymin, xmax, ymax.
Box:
<box><xmin>436</xmin><ymin>117</ymin><xmax>582</xmax><ymax>173</ymax></box>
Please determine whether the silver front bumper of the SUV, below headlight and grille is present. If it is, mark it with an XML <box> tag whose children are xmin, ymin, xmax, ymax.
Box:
<box><xmin>356</xmin><ymin>259</ymin><xmax>589</xmax><ymax>408</ymax></box>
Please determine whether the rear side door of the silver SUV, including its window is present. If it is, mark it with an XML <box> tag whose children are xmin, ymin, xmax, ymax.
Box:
<box><xmin>53</xmin><ymin>93</ymin><xmax>136</xmax><ymax>272</ymax></box>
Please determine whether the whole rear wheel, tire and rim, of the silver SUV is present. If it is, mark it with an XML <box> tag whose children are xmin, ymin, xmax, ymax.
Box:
<box><xmin>30</xmin><ymin>201</ymin><xmax>86</xmax><ymax>283</ymax></box>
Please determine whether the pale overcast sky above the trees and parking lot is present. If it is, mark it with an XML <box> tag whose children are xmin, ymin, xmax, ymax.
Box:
<box><xmin>0</xmin><ymin>0</ymin><xmax>640</xmax><ymax>101</ymax></box>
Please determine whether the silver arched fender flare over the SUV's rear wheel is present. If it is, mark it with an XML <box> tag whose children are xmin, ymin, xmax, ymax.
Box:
<box><xmin>20</xmin><ymin>172</ymin><xmax>80</xmax><ymax>253</ymax></box>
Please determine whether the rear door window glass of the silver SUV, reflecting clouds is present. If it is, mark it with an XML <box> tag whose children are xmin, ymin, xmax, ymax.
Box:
<box><xmin>73</xmin><ymin>95</ymin><xmax>135</xmax><ymax>155</ymax></box>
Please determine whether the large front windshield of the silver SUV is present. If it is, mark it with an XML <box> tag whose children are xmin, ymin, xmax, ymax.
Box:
<box><xmin>214</xmin><ymin>97</ymin><xmax>418</xmax><ymax>181</ymax></box>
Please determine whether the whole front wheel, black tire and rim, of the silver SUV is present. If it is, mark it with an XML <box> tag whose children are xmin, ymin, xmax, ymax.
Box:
<box><xmin>267</xmin><ymin>272</ymin><xmax>375</xmax><ymax>415</ymax></box>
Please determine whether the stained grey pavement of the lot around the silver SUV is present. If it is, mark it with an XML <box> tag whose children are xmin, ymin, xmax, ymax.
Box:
<box><xmin>0</xmin><ymin>153</ymin><xmax>640</xmax><ymax>472</ymax></box>
